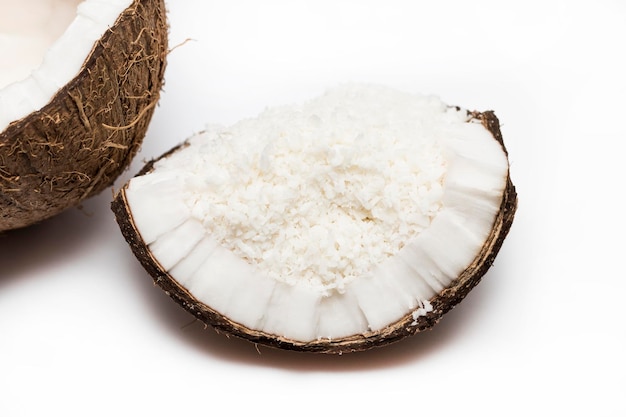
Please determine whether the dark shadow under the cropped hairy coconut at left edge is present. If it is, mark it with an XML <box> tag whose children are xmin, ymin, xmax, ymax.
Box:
<box><xmin>0</xmin><ymin>192</ymin><xmax>110</xmax><ymax>289</ymax></box>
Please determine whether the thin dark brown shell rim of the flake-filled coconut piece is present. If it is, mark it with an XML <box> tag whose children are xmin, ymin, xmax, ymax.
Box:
<box><xmin>111</xmin><ymin>111</ymin><xmax>517</xmax><ymax>354</ymax></box>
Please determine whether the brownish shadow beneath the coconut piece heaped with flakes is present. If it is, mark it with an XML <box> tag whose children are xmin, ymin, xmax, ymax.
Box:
<box><xmin>137</xmin><ymin>256</ymin><xmax>502</xmax><ymax>372</ymax></box>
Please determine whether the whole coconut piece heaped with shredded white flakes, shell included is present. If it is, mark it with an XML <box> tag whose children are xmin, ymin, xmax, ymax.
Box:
<box><xmin>112</xmin><ymin>85</ymin><xmax>517</xmax><ymax>353</ymax></box>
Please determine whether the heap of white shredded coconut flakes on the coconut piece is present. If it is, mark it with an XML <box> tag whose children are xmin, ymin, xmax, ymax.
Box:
<box><xmin>160</xmin><ymin>86</ymin><xmax>467</xmax><ymax>290</ymax></box>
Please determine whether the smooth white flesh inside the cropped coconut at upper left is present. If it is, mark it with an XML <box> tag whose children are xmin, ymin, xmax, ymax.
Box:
<box><xmin>0</xmin><ymin>0</ymin><xmax>132</xmax><ymax>132</ymax></box>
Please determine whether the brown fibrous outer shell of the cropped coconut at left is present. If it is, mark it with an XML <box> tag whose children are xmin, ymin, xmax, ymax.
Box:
<box><xmin>0</xmin><ymin>0</ymin><xmax>168</xmax><ymax>232</ymax></box>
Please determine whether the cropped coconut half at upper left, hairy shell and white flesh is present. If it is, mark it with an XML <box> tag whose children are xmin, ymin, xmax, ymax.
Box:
<box><xmin>0</xmin><ymin>0</ymin><xmax>167</xmax><ymax>231</ymax></box>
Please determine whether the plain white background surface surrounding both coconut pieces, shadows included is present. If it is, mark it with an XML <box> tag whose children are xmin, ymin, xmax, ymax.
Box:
<box><xmin>0</xmin><ymin>0</ymin><xmax>626</xmax><ymax>416</ymax></box>
